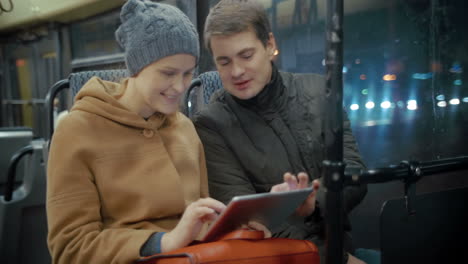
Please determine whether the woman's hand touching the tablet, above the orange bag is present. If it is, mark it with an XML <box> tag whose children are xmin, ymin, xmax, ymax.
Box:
<box><xmin>161</xmin><ymin>198</ymin><xmax>226</xmax><ymax>252</ymax></box>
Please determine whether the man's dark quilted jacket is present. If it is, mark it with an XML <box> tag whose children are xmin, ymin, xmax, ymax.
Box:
<box><xmin>194</xmin><ymin>68</ymin><xmax>367</xmax><ymax>260</ymax></box>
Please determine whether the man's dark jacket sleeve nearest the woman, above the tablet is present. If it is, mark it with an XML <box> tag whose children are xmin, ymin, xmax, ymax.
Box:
<box><xmin>194</xmin><ymin>116</ymin><xmax>256</xmax><ymax>204</ymax></box>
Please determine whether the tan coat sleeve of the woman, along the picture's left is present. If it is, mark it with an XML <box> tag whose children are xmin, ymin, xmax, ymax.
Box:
<box><xmin>46</xmin><ymin>120</ymin><xmax>153</xmax><ymax>264</ymax></box>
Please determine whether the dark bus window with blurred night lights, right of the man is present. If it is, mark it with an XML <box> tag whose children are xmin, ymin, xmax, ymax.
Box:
<box><xmin>254</xmin><ymin>0</ymin><xmax>468</xmax><ymax>167</ymax></box>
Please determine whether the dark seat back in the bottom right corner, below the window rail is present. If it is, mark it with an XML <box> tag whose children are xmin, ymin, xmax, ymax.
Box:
<box><xmin>380</xmin><ymin>187</ymin><xmax>468</xmax><ymax>264</ymax></box>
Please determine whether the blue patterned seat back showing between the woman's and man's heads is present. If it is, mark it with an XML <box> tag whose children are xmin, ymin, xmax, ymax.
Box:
<box><xmin>183</xmin><ymin>71</ymin><xmax>223</xmax><ymax>117</ymax></box>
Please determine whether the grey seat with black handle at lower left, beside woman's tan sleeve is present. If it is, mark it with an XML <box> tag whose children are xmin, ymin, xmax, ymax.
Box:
<box><xmin>0</xmin><ymin>139</ymin><xmax>51</xmax><ymax>264</ymax></box>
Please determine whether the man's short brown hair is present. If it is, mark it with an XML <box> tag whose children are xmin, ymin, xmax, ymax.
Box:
<box><xmin>203</xmin><ymin>0</ymin><xmax>271</xmax><ymax>53</ymax></box>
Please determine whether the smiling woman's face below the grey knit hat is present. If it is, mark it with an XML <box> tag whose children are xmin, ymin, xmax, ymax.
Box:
<box><xmin>132</xmin><ymin>54</ymin><xmax>196</xmax><ymax>117</ymax></box>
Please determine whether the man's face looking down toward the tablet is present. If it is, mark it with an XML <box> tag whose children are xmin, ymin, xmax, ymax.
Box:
<box><xmin>210</xmin><ymin>29</ymin><xmax>276</xmax><ymax>100</ymax></box>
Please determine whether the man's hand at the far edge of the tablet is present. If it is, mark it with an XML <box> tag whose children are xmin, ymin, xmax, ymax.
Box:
<box><xmin>270</xmin><ymin>172</ymin><xmax>320</xmax><ymax>217</ymax></box>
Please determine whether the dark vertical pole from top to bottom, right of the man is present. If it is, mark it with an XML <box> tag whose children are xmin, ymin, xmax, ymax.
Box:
<box><xmin>323</xmin><ymin>0</ymin><xmax>344</xmax><ymax>264</ymax></box>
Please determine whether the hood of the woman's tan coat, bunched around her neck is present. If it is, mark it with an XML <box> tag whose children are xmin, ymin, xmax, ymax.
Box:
<box><xmin>71</xmin><ymin>77</ymin><xmax>176</xmax><ymax>129</ymax></box>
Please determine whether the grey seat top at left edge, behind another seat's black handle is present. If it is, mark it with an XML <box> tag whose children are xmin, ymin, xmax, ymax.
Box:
<box><xmin>0</xmin><ymin>127</ymin><xmax>33</xmax><ymax>195</ymax></box>
